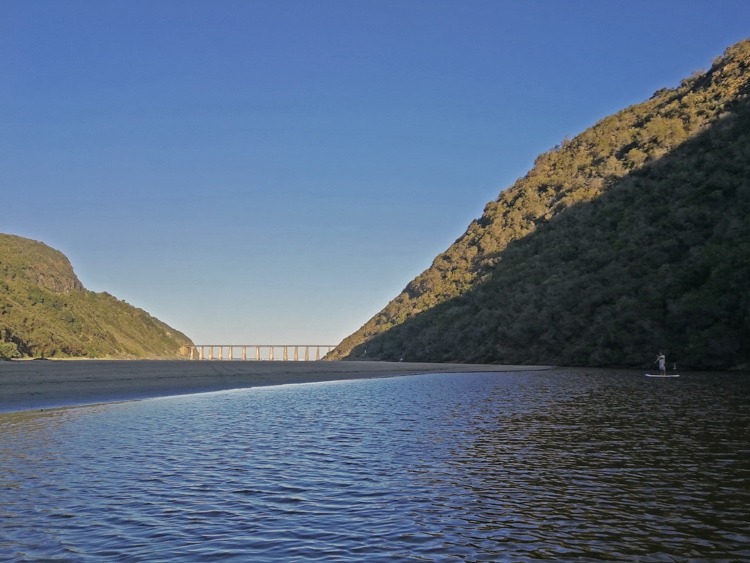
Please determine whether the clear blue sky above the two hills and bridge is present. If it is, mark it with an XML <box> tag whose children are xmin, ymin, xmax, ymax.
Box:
<box><xmin>0</xmin><ymin>0</ymin><xmax>750</xmax><ymax>344</ymax></box>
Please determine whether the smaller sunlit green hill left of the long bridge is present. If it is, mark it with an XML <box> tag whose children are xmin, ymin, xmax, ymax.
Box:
<box><xmin>0</xmin><ymin>234</ymin><xmax>192</xmax><ymax>358</ymax></box>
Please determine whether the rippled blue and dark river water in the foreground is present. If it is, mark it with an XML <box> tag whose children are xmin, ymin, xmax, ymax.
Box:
<box><xmin>0</xmin><ymin>370</ymin><xmax>750</xmax><ymax>562</ymax></box>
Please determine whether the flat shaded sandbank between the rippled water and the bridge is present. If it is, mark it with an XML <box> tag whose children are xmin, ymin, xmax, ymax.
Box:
<box><xmin>0</xmin><ymin>360</ymin><xmax>547</xmax><ymax>412</ymax></box>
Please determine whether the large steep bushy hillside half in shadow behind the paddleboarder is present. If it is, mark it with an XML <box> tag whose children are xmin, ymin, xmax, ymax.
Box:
<box><xmin>327</xmin><ymin>40</ymin><xmax>750</xmax><ymax>368</ymax></box>
